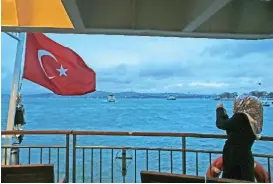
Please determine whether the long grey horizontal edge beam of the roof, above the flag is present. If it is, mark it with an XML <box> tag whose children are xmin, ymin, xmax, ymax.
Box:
<box><xmin>1</xmin><ymin>26</ymin><xmax>273</xmax><ymax>40</ymax></box>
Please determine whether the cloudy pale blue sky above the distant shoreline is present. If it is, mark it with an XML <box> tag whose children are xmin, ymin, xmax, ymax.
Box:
<box><xmin>1</xmin><ymin>33</ymin><xmax>273</xmax><ymax>94</ymax></box>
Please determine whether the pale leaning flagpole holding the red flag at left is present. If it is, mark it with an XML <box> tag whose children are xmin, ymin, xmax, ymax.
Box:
<box><xmin>2</xmin><ymin>33</ymin><xmax>26</xmax><ymax>165</ymax></box>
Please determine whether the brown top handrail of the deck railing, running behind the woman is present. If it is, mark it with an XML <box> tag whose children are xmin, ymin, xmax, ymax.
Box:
<box><xmin>1</xmin><ymin>130</ymin><xmax>273</xmax><ymax>141</ymax></box>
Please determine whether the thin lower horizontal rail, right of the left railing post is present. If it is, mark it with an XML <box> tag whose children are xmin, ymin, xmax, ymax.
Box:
<box><xmin>76</xmin><ymin>146</ymin><xmax>273</xmax><ymax>158</ymax></box>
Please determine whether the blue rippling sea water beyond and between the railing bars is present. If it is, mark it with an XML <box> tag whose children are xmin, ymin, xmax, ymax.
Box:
<box><xmin>1</xmin><ymin>95</ymin><xmax>273</xmax><ymax>182</ymax></box>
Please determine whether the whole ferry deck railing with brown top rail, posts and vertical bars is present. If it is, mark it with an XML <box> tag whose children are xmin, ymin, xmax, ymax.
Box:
<box><xmin>1</xmin><ymin>130</ymin><xmax>273</xmax><ymax>183</ymax></box>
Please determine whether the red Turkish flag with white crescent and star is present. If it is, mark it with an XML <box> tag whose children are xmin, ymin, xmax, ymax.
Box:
<box><xmin>23</xmin><ymin>33</ymin><xmax>96</xmax><ymax>95</ymax></box>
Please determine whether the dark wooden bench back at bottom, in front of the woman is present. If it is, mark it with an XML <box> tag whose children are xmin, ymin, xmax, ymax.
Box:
<box><xmin>140</xmin><ymin>171</ymin><xmax>251</xmax><ymax>183</ymax></box>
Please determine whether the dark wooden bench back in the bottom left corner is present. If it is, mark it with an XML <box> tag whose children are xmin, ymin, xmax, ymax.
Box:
<box><xmin>1</xmin><ymin>164</ymin><xmax>66</xmax><ymax>183</ymax></box>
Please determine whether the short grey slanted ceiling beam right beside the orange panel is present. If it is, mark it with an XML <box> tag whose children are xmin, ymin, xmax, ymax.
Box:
<box><xmin>62</xmin><ymin>0</ymin><xmax>85</xmax><ymax>30</ymax></box>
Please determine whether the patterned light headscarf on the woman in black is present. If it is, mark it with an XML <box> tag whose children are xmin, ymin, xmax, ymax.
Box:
<box><xmin>233</xmin><ymin>96</ymin><xmax>263</xmax><ymax>139</ymax></box>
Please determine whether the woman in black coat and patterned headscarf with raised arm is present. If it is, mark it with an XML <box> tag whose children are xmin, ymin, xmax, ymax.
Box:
<box><xmin>216</xmin><ymin>96</ymin><xmax>263</xmax><ymax>181</ymax></box>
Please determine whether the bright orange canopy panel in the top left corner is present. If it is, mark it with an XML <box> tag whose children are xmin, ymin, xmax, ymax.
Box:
<box><xmin>1</xmin><ymin>0</ymin><xmax>74</xmax><ymax>28</ymax></box>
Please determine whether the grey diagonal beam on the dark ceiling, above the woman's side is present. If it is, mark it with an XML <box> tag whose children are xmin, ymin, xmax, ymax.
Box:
<box><xmin>182</xmin><ymin>0</ymin><xmax>232</xmax><ymax>32</ymax></box>
